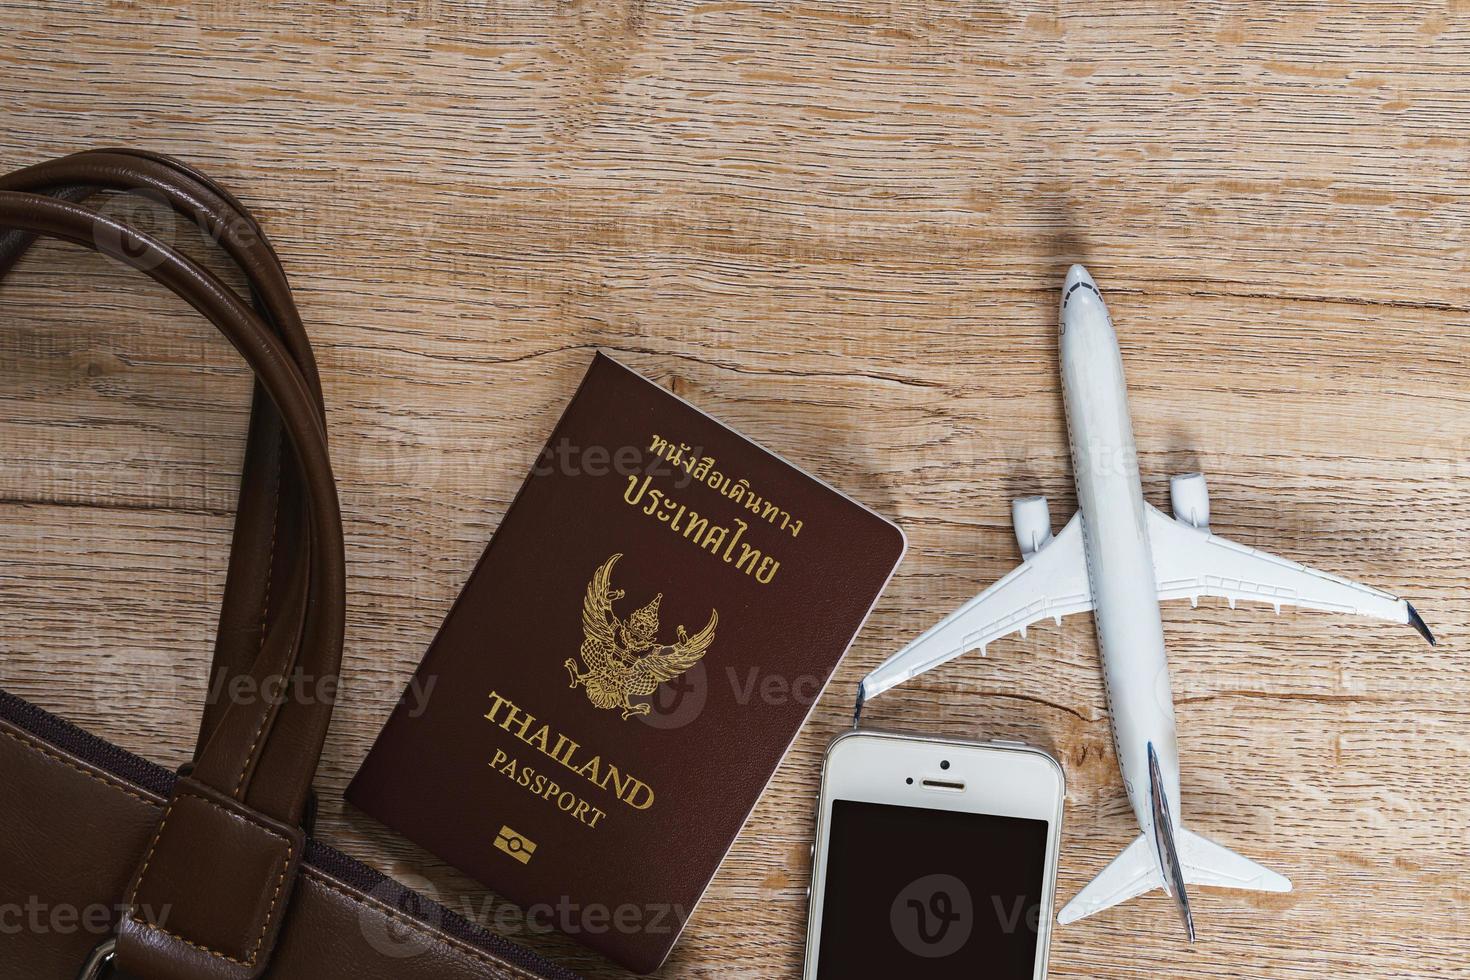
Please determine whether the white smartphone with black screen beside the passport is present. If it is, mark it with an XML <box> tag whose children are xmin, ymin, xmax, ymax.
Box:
<box><xmin>803</xmin><ymin>730</ymin><xmax>1066</xmax><ymax>980</ymax></box>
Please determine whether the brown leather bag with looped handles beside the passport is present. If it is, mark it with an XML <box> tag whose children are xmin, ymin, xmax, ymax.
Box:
<box><xmin>0</xmin><ymin>150</ymin><xmax>572</xmax><ymax>980</ymax></box>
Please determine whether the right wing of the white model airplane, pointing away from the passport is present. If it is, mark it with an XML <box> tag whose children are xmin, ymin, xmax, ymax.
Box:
<box><xmin>1148</xmin><ymin>507</ymin><xmax>1435</xmax><ymax>644</ymax></box>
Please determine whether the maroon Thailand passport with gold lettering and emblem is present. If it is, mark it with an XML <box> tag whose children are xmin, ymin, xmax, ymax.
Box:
<box><xmin>347</xmin><ymin>354</ymin><xmax>904</xmax><ymax>973</ymax></box>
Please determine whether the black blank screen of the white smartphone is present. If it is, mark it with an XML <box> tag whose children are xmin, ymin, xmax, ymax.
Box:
<box><xmin>817</xmin><ymin>799</ymin><xmax>1048</xmax><ymax>980</ymax></box>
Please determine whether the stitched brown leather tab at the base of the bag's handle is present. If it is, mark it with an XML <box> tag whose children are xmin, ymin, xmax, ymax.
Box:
<box><xmin>118</xmin><ymin>779</ymin><xmax>306</xmax><ymax>980</ymax></box>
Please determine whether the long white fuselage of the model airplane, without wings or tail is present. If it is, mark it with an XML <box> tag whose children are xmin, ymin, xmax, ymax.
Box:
<box><xmin>1060</xmin><ymin>282</ymin><xmax>1180</xmax><ymax>835</ymax></box>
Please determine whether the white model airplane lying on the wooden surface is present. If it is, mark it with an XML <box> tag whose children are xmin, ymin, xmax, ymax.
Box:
<box><xmin>858</xmin><ymin>266</ymin><xmax>1435</xmax><ymax>942</ymax></box>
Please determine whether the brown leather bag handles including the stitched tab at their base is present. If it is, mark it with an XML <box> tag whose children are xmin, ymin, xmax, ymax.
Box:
<box><xmin>0</xmin><ymin>151</ymin><xmax>345</xmax><ymax>980</ymax></box>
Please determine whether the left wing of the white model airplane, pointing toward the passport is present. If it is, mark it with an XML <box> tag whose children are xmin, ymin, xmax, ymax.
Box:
<box><xmin>860</xmin><ymin>513</ymin><xmax>1092</xmax><ymax>701</ymax></box>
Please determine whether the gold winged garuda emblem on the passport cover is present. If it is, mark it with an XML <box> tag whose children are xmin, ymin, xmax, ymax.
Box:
<box><xmin>566</xmin><ymin>554</ymin><xmax>720</xmax><ymax>721</ymax></box>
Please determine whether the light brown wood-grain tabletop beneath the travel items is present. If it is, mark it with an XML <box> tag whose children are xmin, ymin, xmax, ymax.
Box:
<box><xmin>0</xmin><ymin>0</ymin><xmax>1470</xmax><ymax>980</ymax></box>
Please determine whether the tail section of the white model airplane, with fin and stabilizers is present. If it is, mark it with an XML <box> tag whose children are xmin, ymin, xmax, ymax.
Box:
<box><xmin>1057</xmin><ymin>746</ymin><xmax>1292</xmax><ymax>942</ymax></box>
